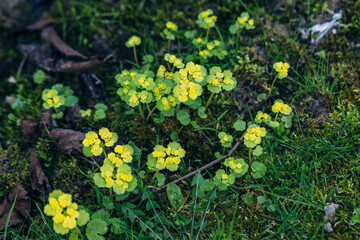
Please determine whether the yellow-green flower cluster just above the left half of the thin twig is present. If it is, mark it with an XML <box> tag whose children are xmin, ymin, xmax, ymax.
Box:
<box><xmin>147</xmin><ymin>142</ymin><xmax>185</xmax><ymax>171</ymax></box>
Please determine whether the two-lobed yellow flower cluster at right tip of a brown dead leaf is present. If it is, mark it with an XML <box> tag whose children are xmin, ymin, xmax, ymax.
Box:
<box><xmin>82</xmin><ymin>128</ymin><xmax>118</xmax><ymax>156</ymax></box>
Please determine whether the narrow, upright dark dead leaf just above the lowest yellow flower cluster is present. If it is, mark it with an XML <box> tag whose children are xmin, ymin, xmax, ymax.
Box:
<box><xmin>29</xmin><ymin>149</ymin><xmax>51</xmax><ymax>196</ymax></box>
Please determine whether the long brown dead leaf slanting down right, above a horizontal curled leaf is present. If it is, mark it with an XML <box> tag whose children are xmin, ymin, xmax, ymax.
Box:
<box><xmin>40</xmin><ymin>27</ymin><xmax>87</xmax><ymax>59</ymax></box>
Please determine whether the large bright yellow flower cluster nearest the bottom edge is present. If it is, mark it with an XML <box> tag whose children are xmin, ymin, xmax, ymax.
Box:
<box><xmin>44</xmin><ymin>190</ymin><xmax>89</xmax><ymax>234</ymax></box>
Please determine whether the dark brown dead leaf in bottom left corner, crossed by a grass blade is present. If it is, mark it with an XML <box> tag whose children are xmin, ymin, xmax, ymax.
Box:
<box><xmin>0</xmin><ymin>184</ymin><xmax>31</xmax><ymax>231</ymax></box>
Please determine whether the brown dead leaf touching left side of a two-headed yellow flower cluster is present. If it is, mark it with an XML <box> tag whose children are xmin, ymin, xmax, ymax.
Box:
<box><xmin>50</xmin><ymin>128</ymin><xmax>85</xmax><ymax>155</ymax></box>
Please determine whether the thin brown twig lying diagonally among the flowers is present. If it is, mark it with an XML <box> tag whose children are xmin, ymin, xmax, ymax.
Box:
<box><xmin>129</xmin><ymin>132</ymin><xmax>246</xmax><ymax>202</ymax></box>
